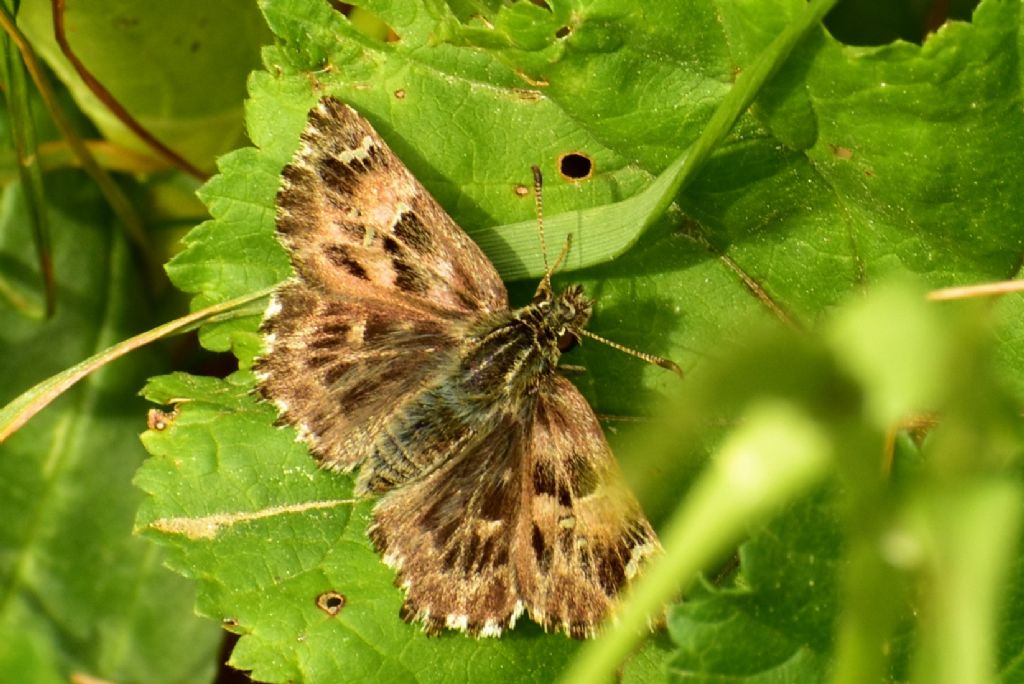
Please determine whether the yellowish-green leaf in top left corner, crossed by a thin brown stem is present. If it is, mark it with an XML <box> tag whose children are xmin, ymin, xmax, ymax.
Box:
<box><xmin>18</xmin><ymin>0</ymin><xmax>269</xmax><ymax>168</ymax></box>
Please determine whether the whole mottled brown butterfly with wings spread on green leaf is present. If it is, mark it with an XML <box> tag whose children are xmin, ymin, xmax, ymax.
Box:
<box><xmin>254</xmin><ymin>97</ymin><xmax>660</xmax><ymax>638</ymax></box>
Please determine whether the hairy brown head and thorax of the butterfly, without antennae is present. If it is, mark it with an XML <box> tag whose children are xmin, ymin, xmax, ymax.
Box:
<box><xmin>462</xmin><ymin>285</ymin><xmax>592</xmax><ymax>398</ymax></box>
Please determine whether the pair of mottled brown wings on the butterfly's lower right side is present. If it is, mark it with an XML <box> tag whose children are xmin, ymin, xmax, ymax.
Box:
<box><xmin>370</xmin><ymin>377</ymin><xmax>660</xmax><ymax>638</ymax></box>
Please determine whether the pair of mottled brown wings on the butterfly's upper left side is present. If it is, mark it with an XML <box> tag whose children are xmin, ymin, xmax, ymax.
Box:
<box><xmin>254</xmin><ymin>97</ymin><xmax>508</xmax><ymax>475</ymax></box>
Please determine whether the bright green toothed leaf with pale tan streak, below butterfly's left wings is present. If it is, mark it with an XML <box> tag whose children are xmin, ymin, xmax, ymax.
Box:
<box><xmin>136</xmin><ymin>373</ymin><xmax>657</xmax><ymax>682</ymax></box>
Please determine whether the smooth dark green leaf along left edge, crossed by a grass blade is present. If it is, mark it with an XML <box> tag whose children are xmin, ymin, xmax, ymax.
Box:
<box><xmin>0</xmin><ymin>172</ymin><xmax>219</xmax><ymax>682</ymax></box>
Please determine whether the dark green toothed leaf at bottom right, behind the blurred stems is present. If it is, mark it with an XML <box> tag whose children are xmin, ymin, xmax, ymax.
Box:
<box><xmin>669</xmin><ymin>494</ymin><xmax>842</xmax><ymax>684</ymax></box>
